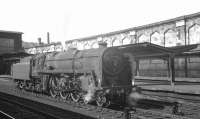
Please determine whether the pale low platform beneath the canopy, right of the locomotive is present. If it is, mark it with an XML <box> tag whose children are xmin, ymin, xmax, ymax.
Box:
<box><xmin>135</xmin><ymin>76</ymin><xmax>200</xmax><ymax>95</ymax></box>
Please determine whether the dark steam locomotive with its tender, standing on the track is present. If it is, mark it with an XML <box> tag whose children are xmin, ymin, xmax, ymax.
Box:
<box><xmin>12</xmin><ymin>45</ymin><xmax>132</xmax><ymax>106</ymax></box>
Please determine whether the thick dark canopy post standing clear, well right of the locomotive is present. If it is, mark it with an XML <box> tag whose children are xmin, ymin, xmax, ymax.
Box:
<box><xmin>169</xmin><ymin>54</ymin><xmax>175</xmax><ymax>86</ymax></box>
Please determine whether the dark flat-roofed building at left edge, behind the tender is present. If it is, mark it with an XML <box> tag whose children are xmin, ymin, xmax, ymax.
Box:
<box><xmin>0</xmin><ymin>30</ymin><xmax>26</xmax><ymax>74</ymax></box>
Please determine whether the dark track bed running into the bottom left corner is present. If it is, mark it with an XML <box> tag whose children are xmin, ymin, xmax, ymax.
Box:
<box><xmin>0</xmin><ymin>92</ymin><xmax>94</xmax><ymax>119</ymax></box>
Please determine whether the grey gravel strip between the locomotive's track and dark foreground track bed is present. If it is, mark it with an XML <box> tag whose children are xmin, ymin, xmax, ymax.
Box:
<box><xmin>0</xmin><ymin>80</ymin><xmax>197</xmax><ymax>119</ymax></box>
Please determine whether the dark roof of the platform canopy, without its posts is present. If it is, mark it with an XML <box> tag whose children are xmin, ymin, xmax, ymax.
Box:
<box><xmin>117</xmin><ymin>42</ymin><xmax>200</xmax><ymax>59</ymax></box>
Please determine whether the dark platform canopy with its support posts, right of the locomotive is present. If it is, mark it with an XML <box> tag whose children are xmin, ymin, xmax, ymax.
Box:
<box><xmin>118</xmin><ymin>42</ymin><xmax>200</xmax><ymax>86</ymax></box>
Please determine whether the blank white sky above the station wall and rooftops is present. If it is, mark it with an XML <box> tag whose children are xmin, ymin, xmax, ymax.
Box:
<box><xmin>0</xmin><ymin>0</ymin><xmax>200</xmax><ymax>45</ymax></box>
